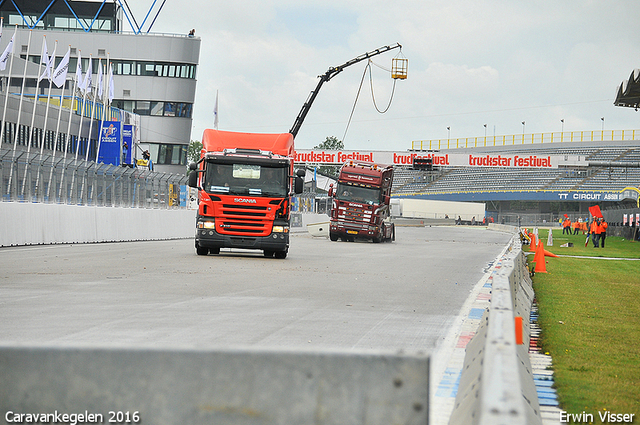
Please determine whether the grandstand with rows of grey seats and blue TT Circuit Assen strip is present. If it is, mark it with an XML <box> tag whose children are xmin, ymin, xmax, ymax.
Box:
<box><xmin>392</xmin><ymin>140</ymin><xmax>640</xmax><ymax>219</ymax></box>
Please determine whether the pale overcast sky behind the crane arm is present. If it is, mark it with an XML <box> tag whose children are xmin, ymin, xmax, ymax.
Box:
<box><xmin>125</xmin><ymin>0</ymin><xmax>640</xmax><ymax>150</ymax></box>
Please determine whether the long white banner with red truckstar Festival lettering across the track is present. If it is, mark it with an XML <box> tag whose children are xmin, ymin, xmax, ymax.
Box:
<box><xmin>295</xmin><ymin>149</ymin><xmax>576</xmax><ymax>168</ymax></box>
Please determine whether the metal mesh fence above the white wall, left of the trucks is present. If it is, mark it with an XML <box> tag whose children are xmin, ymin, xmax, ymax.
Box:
<box><xmin>0</xmin><ymin>149</ymin><xmax>187</xmax><ymax>208</ymax></box>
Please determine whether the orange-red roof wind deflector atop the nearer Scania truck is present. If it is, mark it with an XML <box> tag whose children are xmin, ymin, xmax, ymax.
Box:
<box><xmin>202</xmin><ymin>129</ymin><xmax>294</xmax><ymax>157</ymax></box>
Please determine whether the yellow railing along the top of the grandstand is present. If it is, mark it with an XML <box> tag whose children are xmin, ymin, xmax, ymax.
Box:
<box><xmin>411</xmin><ymin>130</ymin><xmax>640</xmax><ymax>150</ymax></box>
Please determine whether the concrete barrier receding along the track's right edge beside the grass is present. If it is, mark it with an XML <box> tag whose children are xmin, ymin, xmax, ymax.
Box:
<box><xmin>449</xmin><ymin>229</ymin><xmax>542</xmax><ymax>425</ymax></box>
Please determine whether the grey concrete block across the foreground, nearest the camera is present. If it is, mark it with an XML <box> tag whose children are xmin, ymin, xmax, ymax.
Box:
<box><xmin>0</xmin><ymin>346</ymin><xmax>429</xmax><ymax>425</ymax></box>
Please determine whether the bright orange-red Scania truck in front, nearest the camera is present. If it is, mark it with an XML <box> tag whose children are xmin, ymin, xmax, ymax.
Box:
<box><xmin>189</xmin><ymin>129</ymin><xmax>304</xmax><ymax>258</ymax></box>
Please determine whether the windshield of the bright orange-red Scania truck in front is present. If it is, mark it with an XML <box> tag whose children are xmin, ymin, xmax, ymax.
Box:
<box><xmin>204</xmin><ymin>162</ymin><xmax>289</xmax><ymax>197</ymax></box>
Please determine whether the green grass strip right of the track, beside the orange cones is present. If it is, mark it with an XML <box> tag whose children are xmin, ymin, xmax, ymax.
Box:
<box><xmin>525</xmin><ymin>229</ymin><xmax>640</xmax><ymax>423</ymax></box>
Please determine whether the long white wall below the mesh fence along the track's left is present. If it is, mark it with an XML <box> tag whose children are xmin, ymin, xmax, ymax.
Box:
<box><xmin>0</xmin><ymin>202</ymin><xmax>195</xmax><ymax>246</ymax></box>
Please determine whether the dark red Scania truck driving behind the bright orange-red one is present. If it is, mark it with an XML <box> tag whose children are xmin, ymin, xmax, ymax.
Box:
<box><xmin>329</xmin><ymin>161</ymin><xmax>395</xmax><ymax>242</ymax></box>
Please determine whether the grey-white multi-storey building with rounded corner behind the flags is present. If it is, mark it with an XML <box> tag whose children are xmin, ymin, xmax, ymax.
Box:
<box><xmin>0</xmin><ymin>0</ymin><xmax>200</xmax><ymax>173</ymax></box>
